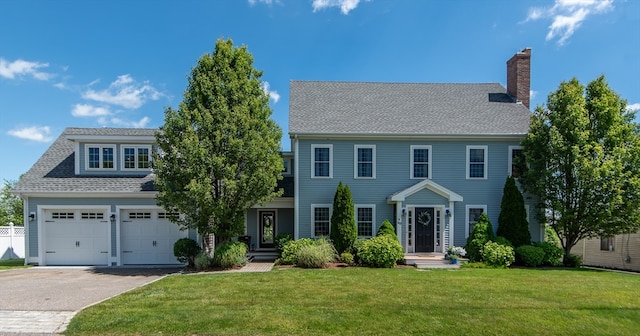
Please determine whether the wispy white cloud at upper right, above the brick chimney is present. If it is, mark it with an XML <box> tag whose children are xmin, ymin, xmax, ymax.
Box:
<box><xmin>522</xmin><ymin>0</ymin><xmax>613</xmax><ymax>46</ymax></box>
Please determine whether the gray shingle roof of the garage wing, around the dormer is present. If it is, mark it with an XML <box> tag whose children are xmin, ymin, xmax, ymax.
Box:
<box><xmin>13</xmin><ymin>127</ymin><xmax>157</xmax><ymax>193</ymax></box>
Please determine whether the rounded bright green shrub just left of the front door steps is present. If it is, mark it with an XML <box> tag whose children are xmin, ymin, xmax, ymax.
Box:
<box><xmin>358</xmin><ymin>235</ymin><xmax>404</xmax><ymax>268</ymax></box>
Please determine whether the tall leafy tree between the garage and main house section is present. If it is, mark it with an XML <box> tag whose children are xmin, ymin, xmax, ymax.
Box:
<box><xmin>153</xmin><ymin>39</ymin><xmax>283</xmax><ymax>249</ymax></box>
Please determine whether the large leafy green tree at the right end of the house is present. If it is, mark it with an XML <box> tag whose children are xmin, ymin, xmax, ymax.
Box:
<box><xmin>520</xmin><ymin>76</ymin><xmax>640</xmax><ymax>261</ymax></box>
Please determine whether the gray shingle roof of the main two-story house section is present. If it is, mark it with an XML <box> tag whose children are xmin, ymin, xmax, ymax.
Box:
<box><xmin>289</xmin><ymin>81</ymin><xmax>530</xmax><ymax>136</ymax></box>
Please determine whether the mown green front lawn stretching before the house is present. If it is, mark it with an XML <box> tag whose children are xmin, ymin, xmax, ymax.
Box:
<box><xmin>66</xmin><ymin>268</ymin><xmax>640</xmax><ymax>335</ymax></box>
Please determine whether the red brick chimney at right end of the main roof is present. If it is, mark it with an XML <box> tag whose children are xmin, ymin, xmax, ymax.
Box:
<box><xmin>507</xmin><ymin>48</ymin><xmax>531</xmax><ymax>108</ymax></box>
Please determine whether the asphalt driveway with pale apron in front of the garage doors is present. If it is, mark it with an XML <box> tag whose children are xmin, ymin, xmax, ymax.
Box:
<box><xmin>0</xmin><ymin>267</ymin><xmax>180</xmax><ymax>334</ymax></box>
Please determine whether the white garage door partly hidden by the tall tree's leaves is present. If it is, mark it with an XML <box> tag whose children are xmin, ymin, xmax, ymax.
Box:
<box><xmin>120</xmin><ymin>210</ymin><xmax>187</xmax><ymax>265</ymax></box>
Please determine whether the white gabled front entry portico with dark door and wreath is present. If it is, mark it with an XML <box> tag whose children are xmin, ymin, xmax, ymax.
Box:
<box><xmin>387</xmin><ymin>179</ymin><xmax>462</xmax><ymax>253</ymax></box>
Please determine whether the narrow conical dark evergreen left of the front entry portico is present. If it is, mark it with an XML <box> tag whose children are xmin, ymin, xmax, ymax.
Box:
<box><xmin>329</xmin><ymin>182</ymin><xmax>358</xmax><ymax>253</ymax></box>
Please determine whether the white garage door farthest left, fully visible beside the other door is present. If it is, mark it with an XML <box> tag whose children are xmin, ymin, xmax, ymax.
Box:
<box><xmin>43</xmin><ymin>210</ymin><xmax>109</xmax><ymax>265</ymax></box>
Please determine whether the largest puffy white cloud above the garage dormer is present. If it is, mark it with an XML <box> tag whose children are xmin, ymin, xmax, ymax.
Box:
<box><xmin>82</xmin><ymin>74</ymin><xmax>162</xmax><ymax>109</ymax></box>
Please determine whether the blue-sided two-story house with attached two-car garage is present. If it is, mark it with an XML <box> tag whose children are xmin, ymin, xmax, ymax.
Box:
<box><xmin>13</xmin><ymin>49</ymin><xmax>544</xmax><ymax>266</ymax></box>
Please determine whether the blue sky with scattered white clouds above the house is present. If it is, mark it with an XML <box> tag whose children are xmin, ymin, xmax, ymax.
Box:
<box><xmin>0</xmin><ymin>0</ymin><xmax>640</xmax><ymax>182</ymax></box>
